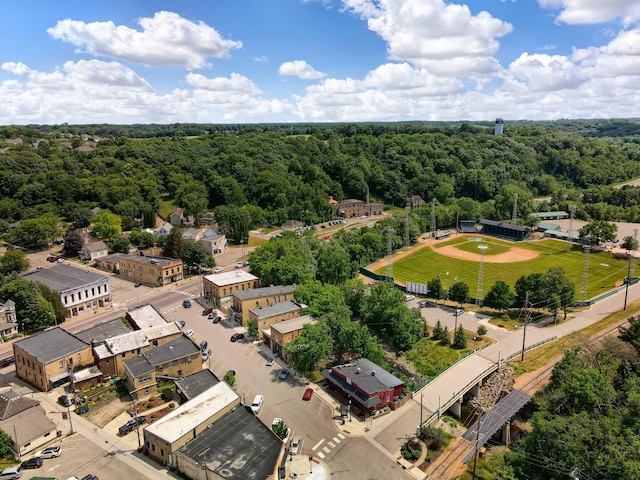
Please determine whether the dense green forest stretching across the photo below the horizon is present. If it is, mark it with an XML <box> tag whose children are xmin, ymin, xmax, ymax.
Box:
<box><xmin>0</xmin><ymin>121</ymin><xmax>640</xmax><ymax>244</ymax></box>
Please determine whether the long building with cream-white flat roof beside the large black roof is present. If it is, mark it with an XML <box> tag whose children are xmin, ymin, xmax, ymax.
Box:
<box><xmin>143</xmin><ymin>382</ymin><xmax>241</xmax><ymax>466</ymax></box>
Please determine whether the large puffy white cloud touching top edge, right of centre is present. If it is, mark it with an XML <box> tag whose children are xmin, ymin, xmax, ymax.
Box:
<box><xmin>342</xmin><ymin>0</ymin><xmax>513</xmax><ymax>76</ymax></box>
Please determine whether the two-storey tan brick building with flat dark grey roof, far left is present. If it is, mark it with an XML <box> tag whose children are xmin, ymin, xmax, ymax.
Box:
<box><xmin>13</xmin><ymin>327</ymin><xmax>94</xmax><ymax>392</ymax></box>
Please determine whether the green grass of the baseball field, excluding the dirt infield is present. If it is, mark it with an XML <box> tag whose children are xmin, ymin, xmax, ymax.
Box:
<box><xmin>376</xmin><ymin>237</ymin><xmax>628</xmax><ymax>299</ymax></box>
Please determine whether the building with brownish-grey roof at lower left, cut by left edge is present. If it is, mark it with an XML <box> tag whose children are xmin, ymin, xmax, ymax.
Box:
<box><xmin>0</xmin><ymin>389</ymin><xmax>56</xmax><ymax>458</ymax></box>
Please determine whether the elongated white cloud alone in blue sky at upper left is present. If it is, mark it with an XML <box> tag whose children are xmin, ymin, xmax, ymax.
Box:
<box><xmin>47</xmin><ymin>11</ymin><xmax>242</xmax><ymax>69</ymax></box>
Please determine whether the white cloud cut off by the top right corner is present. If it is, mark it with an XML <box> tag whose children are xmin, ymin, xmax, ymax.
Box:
<box><xmin>538</xmin><ymin>0</ymin><xmax>640</xmax><ymax>25</ymax></box>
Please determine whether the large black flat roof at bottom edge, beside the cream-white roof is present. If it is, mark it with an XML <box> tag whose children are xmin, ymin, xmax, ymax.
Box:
<box><xmin>178</xmin><ymin>407</ymin><xmax>283</xmax><ymax>480</ymax></box>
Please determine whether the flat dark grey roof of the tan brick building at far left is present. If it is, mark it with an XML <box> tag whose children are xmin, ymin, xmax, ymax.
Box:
<box><xmin>13</xmin><ymin>327</ymin><xmax>89</xmax><ymax>364</ymax></box>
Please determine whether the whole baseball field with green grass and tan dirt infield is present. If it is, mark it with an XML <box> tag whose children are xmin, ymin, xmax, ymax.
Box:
<box><xmin>374</xmin><ymin>235</ymin><xmax>628</xmax><ymax>300</ymax></box>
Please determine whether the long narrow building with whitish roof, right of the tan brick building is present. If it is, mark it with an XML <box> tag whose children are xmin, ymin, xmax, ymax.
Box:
<box><xmin>93</xmin><ymin>322</ymin><xmax>182</xmax><ymax>376</ymax></box>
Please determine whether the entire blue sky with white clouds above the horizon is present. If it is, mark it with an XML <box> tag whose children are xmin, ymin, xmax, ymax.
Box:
<box><xmin>0</xmin><ymin>0</ymin><xmax>640</xmax><ymax>124</ymax></box>
